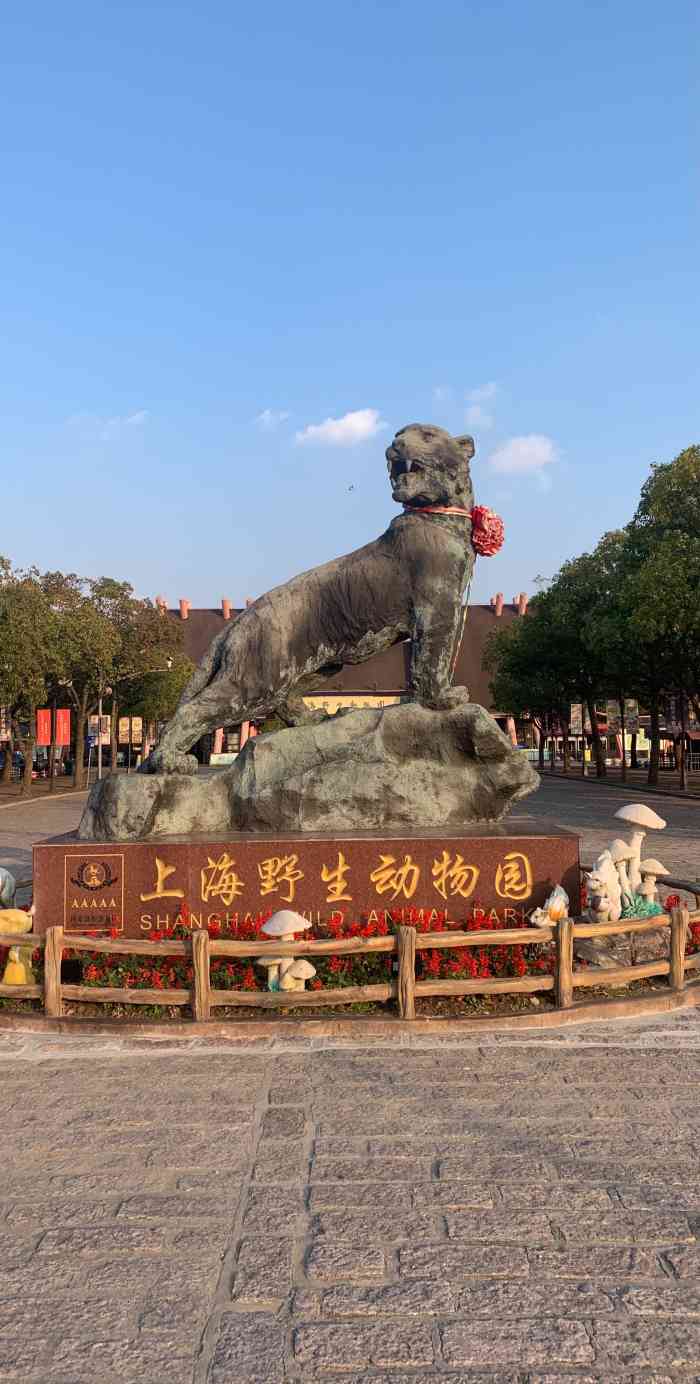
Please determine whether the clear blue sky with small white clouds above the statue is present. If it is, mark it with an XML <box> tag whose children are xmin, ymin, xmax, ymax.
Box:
<box><xmin>0</xmin><ymin>0</ymin><xmax>700</xmax><ymax>605</ymax></box>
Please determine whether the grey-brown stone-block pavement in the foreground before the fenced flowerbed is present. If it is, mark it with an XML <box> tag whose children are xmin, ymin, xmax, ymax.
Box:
<box><xmin>6</xmin><ymin>1010</ymin><xmax>700</xmax><ymax>1384</ymax></box>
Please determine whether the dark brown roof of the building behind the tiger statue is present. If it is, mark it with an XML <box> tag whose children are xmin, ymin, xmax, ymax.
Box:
<box><xmin>169</xmin><ymin>605</ymin><xmax>517</xmax><ymax>711</ymax></box>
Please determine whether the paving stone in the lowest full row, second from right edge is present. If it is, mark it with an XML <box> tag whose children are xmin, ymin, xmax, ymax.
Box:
<box><xmin>440</xmin><ymin>1318</ymin><xmax>593</xmax><ymax>1367</ymax></box>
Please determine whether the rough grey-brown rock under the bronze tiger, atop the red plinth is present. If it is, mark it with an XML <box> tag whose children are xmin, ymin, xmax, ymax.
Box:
<box><xmin>79</xmin><ymin>689</ymin><xmax>540</xmax><ymax>841</ymax></box>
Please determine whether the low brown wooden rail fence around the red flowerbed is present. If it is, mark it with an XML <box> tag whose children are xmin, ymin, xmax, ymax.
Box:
<box><xmin>0</xmin><ymin>902</ymin><xmax>700</xmax><ymax>1023</ymax></box>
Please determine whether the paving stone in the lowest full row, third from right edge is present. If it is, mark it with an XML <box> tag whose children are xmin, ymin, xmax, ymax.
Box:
<box><xmin>293</xmin><ymin>1320</ymin><xmax>434</xmax><ymax>1372</ymax></box>
